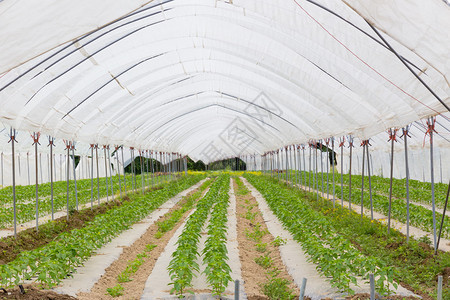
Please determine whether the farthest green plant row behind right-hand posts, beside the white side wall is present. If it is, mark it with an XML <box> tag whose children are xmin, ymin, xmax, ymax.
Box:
<box><xmin>283</xmin><ymin>170</ymin><xmax>448</xmax><ymax>208</ymax></box>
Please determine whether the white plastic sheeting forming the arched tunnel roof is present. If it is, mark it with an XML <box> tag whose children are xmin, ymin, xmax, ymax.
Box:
<box><xmin>0</xmin><ymin>0</ymin><xmax>450</xmax><ymax>163</ymax></box>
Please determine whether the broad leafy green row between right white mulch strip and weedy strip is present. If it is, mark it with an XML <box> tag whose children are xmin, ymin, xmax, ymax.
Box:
<box><xmin>245</xmin><ymin>174</ymin><xmax>395</xmax><ymax>293</ymax></box>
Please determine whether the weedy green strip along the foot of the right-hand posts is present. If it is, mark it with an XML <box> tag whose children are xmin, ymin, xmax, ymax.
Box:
<box><xmin>251</xmin><ymin>176</ymin><xmax>450</xmax><ymax>299</ymax></box>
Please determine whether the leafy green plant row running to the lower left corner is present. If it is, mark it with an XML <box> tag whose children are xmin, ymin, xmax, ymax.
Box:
<box><xmin>0</xmin><ymin>175</ymin><xmax>204</xmax><ymax>287</ymax></box>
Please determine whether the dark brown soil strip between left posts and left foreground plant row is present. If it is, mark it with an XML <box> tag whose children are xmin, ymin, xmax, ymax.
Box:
<box><xmin>0</xmin><ymin>197</ymin><xmax>125</xmax><ymax>265</ymax></box>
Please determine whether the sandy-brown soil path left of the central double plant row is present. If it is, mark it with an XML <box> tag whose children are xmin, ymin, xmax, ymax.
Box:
<box><xmin>77</xmin><ymin>184</ymin><xmax>206</xmax><ymax>300</ymax></box>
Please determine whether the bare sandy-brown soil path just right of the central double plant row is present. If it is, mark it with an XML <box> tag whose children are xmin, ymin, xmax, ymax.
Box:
<box><xmin>233</xmin><ymin>180</ymin><xmax>300</xmax><ymax>300</ymax></box>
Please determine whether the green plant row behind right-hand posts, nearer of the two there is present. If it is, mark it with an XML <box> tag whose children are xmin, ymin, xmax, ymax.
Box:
<box><xmin>284</xmin><ymin>173</ymin><xmax>450</xmax><ymax>238</ymax></box>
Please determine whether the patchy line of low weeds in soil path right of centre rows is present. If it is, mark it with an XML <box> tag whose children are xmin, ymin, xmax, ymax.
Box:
<box><xmin>235</xmin><ymin>177</ymin><xmax>295</xmax><ymax>300</ymax></box>
